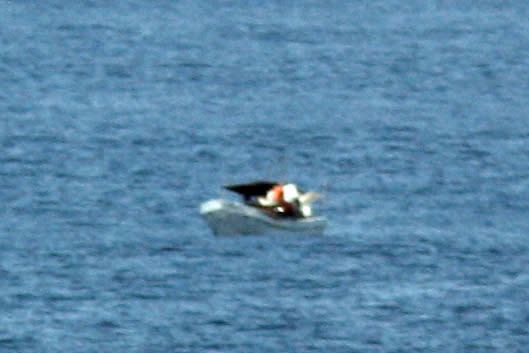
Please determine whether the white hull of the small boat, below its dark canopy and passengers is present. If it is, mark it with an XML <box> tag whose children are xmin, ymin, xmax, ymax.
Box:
<box><xmin>200</xmin><ymin>199</ymin><xmax>327</xmax><ymax>235</ymax></box>
